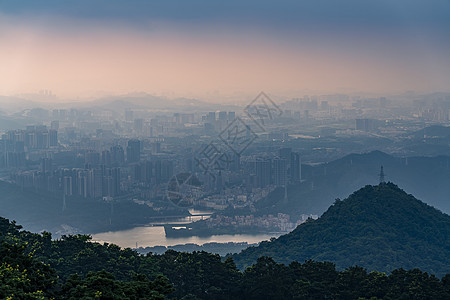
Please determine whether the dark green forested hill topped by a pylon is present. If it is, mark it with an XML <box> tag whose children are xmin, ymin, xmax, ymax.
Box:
<box><xmin>233</xmin><ymin>183</ymin><xmax>450</xmax><ymax>275</ymax></box>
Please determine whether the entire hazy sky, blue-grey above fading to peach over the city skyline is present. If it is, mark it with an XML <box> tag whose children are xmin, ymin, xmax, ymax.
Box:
<box><xmin>0</xmin><ymin>0</ymin><xmax>450</xmax><ymax>101</ymax></box>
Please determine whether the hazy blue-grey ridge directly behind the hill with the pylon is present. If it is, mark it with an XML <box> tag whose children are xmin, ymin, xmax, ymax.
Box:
<box><xmin>256</xmin><ymin>151</ymin><xmax>450</xmax><ymax>215</ymax></box>
